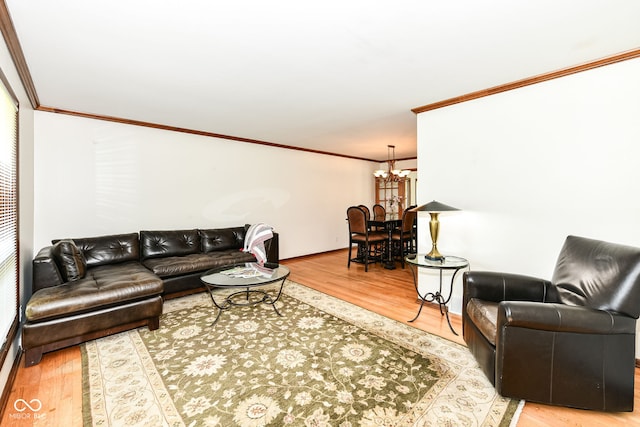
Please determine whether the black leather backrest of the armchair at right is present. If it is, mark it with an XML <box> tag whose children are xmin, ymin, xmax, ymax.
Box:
<box><xmin>551</xmin><ymin>236</ymin><xmax>640</xmax><ymax>319</ymax></box>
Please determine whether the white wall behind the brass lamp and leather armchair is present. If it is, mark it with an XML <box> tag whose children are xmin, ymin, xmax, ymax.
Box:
<box><xmin>418</xmin><ymin>59</ymin><xmax>640</xmax><ymax>324</ymax></box>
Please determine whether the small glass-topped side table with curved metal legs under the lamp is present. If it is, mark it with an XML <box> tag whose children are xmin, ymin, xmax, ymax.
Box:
<box><xmin>405</xmin><ymin>254</ymin><xmax>469</xmax><ymax>335</ymax></box>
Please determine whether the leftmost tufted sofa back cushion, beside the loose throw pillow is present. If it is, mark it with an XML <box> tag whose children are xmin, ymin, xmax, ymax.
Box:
<box><xmin>52</xmin><ymin>233</ymin><xmax>140</xmax><ymax>267</ymax></box>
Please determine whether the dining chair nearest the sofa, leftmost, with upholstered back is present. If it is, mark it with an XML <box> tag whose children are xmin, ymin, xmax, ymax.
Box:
<box><xmin>347</xmin><ymin>206</ymin><xmax>387</xmax><ymax>271</ymax></box>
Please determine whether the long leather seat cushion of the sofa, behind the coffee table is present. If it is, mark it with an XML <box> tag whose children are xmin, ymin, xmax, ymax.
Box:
<box><xmin>143</xmin><ymin>249</ymin><xmax>256</xmax><ymax>278</ymax></box>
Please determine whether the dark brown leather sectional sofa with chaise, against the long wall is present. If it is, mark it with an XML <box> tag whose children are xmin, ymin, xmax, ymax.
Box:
<box><xmin>22</xmin><ymin>225</ymin><xmax>279</xmax><ymax>366</ymax></box>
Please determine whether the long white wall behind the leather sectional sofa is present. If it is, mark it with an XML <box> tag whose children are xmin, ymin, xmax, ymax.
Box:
<box><xmin>34</xmin><ymin>112</ymin><xmax>377</xmax><ymax>262</ymax></box>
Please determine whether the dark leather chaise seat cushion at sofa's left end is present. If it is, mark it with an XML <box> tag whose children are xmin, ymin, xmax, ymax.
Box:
<box><xmin>26</xmin><ymin>262</ymin><xmax>163</xmax><ymax>322</ymax></box>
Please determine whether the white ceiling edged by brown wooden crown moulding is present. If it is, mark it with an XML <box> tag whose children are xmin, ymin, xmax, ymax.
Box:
<box><xmin>5</xmin><ymin>0</ymin><xmax>640</xmax><ymax>160</ymax></box>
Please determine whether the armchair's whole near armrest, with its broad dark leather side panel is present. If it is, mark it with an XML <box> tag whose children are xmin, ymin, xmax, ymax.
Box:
<box><xmin>495</xmin><ymin>301</ymin><xmax>636</xmax><ymax>411</ymax></box>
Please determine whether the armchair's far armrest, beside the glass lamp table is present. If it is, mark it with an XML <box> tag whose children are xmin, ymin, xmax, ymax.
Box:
<box><xmin>462</xmin><ymin>270</ymin><xmax>551</xmax><ymax>307</ymax></box>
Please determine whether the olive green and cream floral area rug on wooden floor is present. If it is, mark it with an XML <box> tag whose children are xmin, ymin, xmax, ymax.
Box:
<box><xmin>82</xmin><ymin>281</ymin><xmax>519</xmax><ymax>427</ymax></box>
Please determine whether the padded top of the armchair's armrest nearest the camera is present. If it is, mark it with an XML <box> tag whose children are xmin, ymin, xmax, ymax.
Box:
<box><xmin>496</xmin><ymin>301</ymin><xmax>636</xmax><ymax>336</ymax></box>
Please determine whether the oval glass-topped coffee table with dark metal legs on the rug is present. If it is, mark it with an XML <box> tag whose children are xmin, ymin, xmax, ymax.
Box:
<box><xmin>200</xmin><ymin>262</ymin><xmax>289</xmax><ymax>326</ymax></box>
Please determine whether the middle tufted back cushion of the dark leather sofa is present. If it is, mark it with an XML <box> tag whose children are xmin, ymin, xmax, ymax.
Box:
<box><xmin>140</xmin><ymin>229</ymin><xmax>200</xmax><ymax>260</ymax></box>
